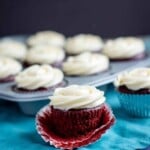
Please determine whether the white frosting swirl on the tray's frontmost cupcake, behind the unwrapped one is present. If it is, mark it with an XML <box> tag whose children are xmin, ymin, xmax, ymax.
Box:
<box><xmin>15</xmin><ymin>65</ymin><xmax>64</xmax><ymax>90</ymax></box>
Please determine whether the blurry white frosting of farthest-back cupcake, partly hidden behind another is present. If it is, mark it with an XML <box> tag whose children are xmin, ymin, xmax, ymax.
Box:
<box><xmin>27</xmin><ymin>31</ymin><xmax>65</xmax><ymax>47</ymax></box>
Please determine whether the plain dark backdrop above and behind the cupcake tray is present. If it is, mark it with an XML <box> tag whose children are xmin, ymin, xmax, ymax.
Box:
<box><xmin>0</xmin><ymin>0</ymin><xmax>150</xmax><ymax>37</ymax></box>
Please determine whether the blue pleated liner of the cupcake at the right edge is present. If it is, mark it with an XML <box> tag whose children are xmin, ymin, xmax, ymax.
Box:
<box><xmin>117</xmin><ymin>91</ymin><xmax>150</xmax><ymax>117</ymax></box>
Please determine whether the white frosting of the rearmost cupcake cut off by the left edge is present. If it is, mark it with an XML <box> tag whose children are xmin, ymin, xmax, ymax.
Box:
<box><xmin>0</xmin><ymin>39</ymin><xmax>27</xmax><ymax>61</ymax></box>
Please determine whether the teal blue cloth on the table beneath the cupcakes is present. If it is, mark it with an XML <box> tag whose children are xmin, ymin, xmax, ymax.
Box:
<box><xmin>0</xmin><ymin>85</ymin><xmax>150</xmax><ymax>150</ymax></box>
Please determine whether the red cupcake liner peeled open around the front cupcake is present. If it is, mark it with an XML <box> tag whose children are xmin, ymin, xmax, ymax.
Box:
<box><xmin>36</xmin><ymin>104</ymin><xmax>115</xmax><ymax>150</ymax></box>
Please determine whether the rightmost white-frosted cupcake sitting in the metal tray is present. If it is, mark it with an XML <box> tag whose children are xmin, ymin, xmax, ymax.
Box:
<box><xmin>102</xmin><ymin>37</ymin><xmax>145</xmax><ymax>61</ymax></box>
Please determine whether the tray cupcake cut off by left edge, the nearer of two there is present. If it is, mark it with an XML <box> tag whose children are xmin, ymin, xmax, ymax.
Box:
<box><xmin>0</xmin><ymin>56</ymin><xmax>22</xmax><ymax>83</ymax></box>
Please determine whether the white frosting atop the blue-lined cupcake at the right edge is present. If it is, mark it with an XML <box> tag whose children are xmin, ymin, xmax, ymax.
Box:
<box><xmin>114</xmin><ymin>68</ymin><xmax>150</xmax><ymax>91</ymax></box>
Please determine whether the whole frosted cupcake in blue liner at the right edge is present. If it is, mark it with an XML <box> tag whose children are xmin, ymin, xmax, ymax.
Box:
<box><xmin>114</xmin><ymin>68</ymin><xmax>150</xmax><ymax>117</ymax></box>
